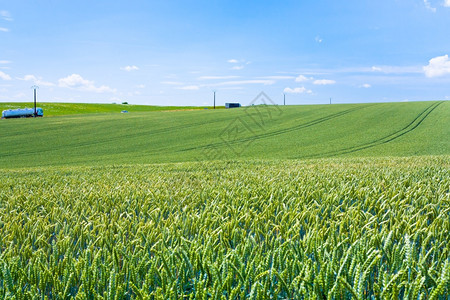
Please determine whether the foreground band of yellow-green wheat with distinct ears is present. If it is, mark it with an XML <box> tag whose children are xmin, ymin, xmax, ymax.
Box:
<box><xmin>0</xmin><ymin>156</ymin><xmax>450</xmax><ymax>299</ymax></box>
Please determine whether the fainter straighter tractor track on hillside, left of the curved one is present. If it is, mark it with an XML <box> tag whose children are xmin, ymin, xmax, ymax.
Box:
<box><xmin>178</xmin><ymin>104</ymin><xmax>375</xmax><ymax>152</ymax></box>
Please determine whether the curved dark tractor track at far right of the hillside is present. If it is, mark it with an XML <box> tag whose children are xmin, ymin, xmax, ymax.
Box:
<box><xmin>304</xmin><ymin>101</ymin><xmax>444</xmax><ymax>158</ymax></box>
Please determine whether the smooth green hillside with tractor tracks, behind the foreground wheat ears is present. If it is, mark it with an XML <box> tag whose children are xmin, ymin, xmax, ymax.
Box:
<box><xmin>0</xmin><ymin>101</ymin><xmax>450</xmax><ymax>168</ymax></box>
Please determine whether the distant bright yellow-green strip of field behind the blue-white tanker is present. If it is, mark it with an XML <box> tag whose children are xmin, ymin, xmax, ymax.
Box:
<box><xmin>0</xmin><ymin>102</ymin><xmax>222</xmax><ymax>117</ymax></box>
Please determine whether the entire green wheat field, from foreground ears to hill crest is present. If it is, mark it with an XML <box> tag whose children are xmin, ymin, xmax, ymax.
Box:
<box><xmin>0</xmin><ymin>101</ymin><xmax>450</xmax><ymax>299</ymax></box>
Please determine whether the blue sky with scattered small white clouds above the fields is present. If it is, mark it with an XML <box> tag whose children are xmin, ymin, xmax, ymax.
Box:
<box><xmin>0</xmin><ymin>0</ymin><xmax>450</xmax><ymax>106</ymax></box>
